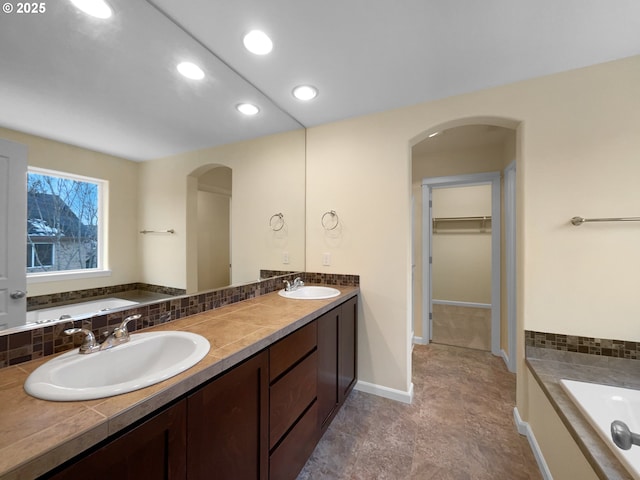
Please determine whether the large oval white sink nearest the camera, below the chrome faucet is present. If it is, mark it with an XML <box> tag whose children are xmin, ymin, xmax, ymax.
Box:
<box><xmin>24</xmin><ymin>331</ymin><xmax>210</xmax><ymax>401</ymax></box>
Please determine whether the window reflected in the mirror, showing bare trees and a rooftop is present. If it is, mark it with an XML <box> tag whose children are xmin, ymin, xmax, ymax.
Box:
<box><xmin>26</xmin><ymin>168</ymin><xmax>107</xmax><ymax>278</ymax></box>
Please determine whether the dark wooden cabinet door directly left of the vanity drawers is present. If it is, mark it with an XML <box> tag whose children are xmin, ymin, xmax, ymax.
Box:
<box><xmin>189</xmin><ymin>351</ymin><xmax>269</xmax><ymax>480</ymax></box>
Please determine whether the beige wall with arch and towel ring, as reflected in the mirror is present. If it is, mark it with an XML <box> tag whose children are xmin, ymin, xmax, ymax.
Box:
<box><xmin>139</xmin><ymin>130</ymin><xmax>305</xmax><ymax>292</ymax></box>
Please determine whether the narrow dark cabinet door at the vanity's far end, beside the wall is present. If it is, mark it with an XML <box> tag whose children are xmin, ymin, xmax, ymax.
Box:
<box><xmin>338</xmin><ymin>297</ymin><xmax>358</xmax><ymax>405</ymax></box>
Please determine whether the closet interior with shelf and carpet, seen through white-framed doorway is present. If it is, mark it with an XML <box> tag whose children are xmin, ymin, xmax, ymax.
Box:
<box><xmin>432</xmin><ymin>185</ymin><xmax>492</xmax><ymax>351</ymax></box>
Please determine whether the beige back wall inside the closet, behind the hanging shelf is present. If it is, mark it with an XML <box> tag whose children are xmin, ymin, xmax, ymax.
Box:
<box><xmin>431</xmin><ymin>185</ymin><xmax>491</xmax><ymax>304</ymax></box>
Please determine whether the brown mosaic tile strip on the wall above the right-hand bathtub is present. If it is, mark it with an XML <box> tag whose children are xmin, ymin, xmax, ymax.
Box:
<box><xmin>524</xmin><ymin>330</ymin><xmax>640</xmax><ymax>360</ymax></box>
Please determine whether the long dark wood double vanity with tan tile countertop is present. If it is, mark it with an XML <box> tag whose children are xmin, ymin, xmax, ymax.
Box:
<box><xmin>0</xmin><ymin>287</ymin><xmax>358</xmax><ymax>480</ymax></box>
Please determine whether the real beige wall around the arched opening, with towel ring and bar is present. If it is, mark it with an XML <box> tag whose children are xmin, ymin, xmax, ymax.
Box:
<box><xmin>307</xmin><ymin>57</ymin><xmax>640</xmax><ymax>404</ymax></box>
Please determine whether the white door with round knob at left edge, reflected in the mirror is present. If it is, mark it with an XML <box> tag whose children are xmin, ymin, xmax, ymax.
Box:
<box><xmin>0</xmin><ymin>135</ymin><xmax>27</xmax><ymax>330</ymax></box>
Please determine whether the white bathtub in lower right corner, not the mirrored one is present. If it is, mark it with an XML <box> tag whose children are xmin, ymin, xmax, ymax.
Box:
<box><xmin>560</xmin><ymin>379</ymin><xmax>640</xmax><ymax>480</ymax></box>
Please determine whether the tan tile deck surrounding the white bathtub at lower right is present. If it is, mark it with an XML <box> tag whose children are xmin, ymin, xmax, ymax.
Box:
<box><xmin>526</xmin><ymin>346</ymin><xmax>640</xmax><ymax>480</ymax></box>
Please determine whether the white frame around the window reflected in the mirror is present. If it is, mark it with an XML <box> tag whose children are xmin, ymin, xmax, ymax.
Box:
<box><xmin>25</xmin><ymin>166</ymin><xmax>111</xmax><ymax>284</ymax></box>
